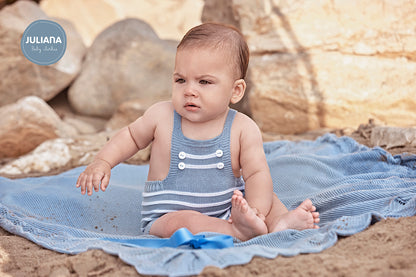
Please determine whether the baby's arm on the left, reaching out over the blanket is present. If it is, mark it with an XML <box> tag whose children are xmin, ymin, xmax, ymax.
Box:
<box><xmin>76</xmin><ymin>101</ymin><xmax>159</xmax><ymax>195</ymax></box>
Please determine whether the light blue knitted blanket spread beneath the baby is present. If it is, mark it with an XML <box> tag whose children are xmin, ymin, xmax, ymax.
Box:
<box><xmin>0</xmin><ymin>134</ymin><xmax>416</xmax><ymax>275</ymax></box>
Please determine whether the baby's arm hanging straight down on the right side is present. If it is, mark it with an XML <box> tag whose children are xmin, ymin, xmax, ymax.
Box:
<box><xmin>238</xmin><ymin>114</ymin><xmax>274</xmax><ymax>217</ymax></box>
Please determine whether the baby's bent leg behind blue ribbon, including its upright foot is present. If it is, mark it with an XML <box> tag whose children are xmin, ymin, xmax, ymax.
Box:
<box><xmin>150</xmin><ymin>192</ymin><xmax>267</xmax><ymax>241</ymax></box>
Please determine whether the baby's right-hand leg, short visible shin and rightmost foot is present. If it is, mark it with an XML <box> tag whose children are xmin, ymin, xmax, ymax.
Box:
<box><xmin>266</xmin><ymin>196</ymin><xmax>319</xmax><ymax>233</ymax></box>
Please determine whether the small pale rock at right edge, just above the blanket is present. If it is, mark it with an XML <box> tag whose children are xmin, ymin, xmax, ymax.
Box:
<box><xmin>370</xmin><ymin>126</ymin><xmax>416</xmax><ymax>149</ymax></box>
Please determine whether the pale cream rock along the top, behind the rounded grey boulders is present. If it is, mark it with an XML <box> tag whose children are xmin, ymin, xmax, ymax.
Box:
<box><xmin>40</xmin><ymin>0</ymin><xmax>204</xmax><ymax>46</ymax></box>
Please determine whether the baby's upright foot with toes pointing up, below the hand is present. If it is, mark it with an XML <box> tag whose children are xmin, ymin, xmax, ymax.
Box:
<box><xmin>230</xmin><ymin>190</ymin><xmax>267</xmax><ymax>241</ymax></box>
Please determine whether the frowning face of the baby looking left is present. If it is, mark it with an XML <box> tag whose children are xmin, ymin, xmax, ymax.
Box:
<box><xmin>172</xmin><ymin>47</ymin><xmax>237</xmax><ymax>122</ymax></box>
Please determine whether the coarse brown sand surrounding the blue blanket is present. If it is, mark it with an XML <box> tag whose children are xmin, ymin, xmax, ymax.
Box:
<box><xmin>0</xmin><ymin>128</ymin><xmax>416</xmax><ymax>277</ymax></box>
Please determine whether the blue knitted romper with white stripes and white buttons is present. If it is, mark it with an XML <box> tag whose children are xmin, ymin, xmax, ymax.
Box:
<box><xmin>141</xmin><ymin>109</ymin><xmax>244</xmax><ymax>234</ymax></box>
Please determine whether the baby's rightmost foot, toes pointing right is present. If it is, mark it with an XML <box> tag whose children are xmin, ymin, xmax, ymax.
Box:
<box><xmin>270</xmin><ymin>199</ymin><xmax>319</xmax><ymax>233</ymax></box>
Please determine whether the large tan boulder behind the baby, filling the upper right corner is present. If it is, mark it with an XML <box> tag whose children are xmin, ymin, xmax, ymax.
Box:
<box><xmin>203</xmin><ymin>0</ymin><xmax>416</xmax><ymax>134</ymax></box>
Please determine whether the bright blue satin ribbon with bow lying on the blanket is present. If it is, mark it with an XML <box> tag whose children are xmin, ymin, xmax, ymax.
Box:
<box><xmin>102</xmin><ymin>228</ymin><xmax>234</xmax><ymax>249</ymax></box>
